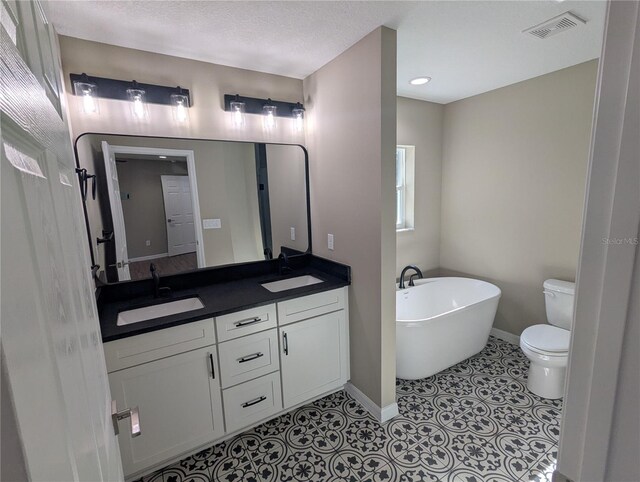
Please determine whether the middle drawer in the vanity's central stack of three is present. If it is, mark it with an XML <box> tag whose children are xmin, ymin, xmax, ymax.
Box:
<box><xmin>218</xmin><ymin>328</ymin><xmax>280</xmax><ymax>388</ymax></box>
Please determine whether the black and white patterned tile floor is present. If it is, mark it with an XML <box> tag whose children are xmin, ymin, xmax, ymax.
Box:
<box><xmin>143</xmin><ymin>337</ymin><xmax>562</xmax><ymax>482</ymax></box>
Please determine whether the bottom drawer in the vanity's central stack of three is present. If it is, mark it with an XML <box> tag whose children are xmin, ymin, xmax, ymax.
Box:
<box><xmin>222</xmin><ymin>372</ymin><xmax>282</xmax><ymax>433</ymax></box>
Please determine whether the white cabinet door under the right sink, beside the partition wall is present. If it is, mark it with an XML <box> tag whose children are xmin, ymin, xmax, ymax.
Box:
<box><xmin>280</xmin><ymin>310</ymin><xmax>347</xmax><ymax>409</ymax></box>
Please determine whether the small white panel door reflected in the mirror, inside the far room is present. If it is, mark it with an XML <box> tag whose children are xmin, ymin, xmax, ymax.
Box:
<box><xmin>160</xmin><ymin>176</ymin><xmax>196</xmax><ymax>256</ymax></box>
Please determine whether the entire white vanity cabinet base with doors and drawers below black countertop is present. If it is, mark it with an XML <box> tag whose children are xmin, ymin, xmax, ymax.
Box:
<box><xmin>104</xmin><ymin>287</ymin><xmax>349</xmax><ymax>478</ymax></box>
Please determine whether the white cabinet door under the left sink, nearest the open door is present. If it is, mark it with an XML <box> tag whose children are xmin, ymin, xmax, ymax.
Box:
<box><xmin>109</xmin><ymin>346</ymin><xmax>224</xmax><ymax>476</ymax></box>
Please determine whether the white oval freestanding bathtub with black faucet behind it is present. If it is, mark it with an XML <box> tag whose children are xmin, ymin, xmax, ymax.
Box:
<box><xmin>396</xmin><ymin>278</ymin><xmax>501</xmax><ymax>380</ymax></box>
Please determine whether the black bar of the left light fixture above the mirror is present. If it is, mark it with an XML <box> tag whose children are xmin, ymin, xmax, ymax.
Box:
<box><xmin>69</xmin><ymin>74</ymin><xmax>192</xmax><ymax>107</ymax></box>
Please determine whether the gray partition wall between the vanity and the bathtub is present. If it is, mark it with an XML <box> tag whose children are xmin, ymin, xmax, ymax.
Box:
<box><xmin>304</xmin><ymin>27</ymin><xmax>396</xmax><ymax>406</ymax></box>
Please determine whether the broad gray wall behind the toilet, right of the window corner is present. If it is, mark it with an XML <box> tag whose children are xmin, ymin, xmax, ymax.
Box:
<box><xmin>440</xmin><ymin>61</ymin><xmax>598</xmax><ymax>335</ymax></box>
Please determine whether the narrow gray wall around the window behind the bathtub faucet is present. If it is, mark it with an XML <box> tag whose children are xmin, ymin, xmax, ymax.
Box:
<box><xmin>396</xmin><ymin>97</ymin><xmax>444</xmax><ymax>276</ymax></box>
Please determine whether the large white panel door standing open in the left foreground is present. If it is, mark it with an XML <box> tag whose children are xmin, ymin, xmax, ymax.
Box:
<box><xmin>0</xmin><ymin>2</ymin><xmax>123</xmax><ymax>481</ymax></box>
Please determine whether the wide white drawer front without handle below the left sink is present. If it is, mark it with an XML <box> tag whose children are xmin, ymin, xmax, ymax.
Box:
<box><xmin>103</xmin><ymin>318</ymin><xmax>216</xmax><ymax>373</ymax></box>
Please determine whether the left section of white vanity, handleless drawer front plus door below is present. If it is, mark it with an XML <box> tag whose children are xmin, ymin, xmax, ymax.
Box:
<box><xmin>105</xmin><ymin>319</ymin><xmax>225</xmax><ymax>475</ymax></box>
